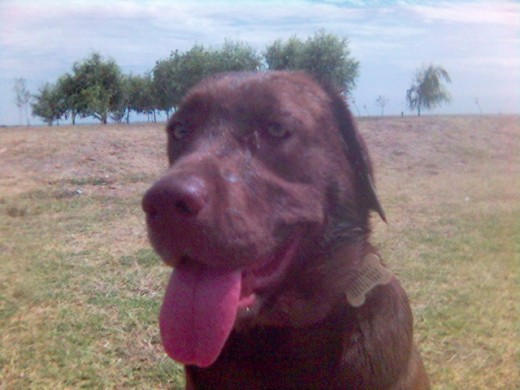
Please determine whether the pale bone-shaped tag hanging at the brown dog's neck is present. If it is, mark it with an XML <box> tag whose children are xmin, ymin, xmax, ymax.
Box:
<box><xmin>345</xmin><ymin>253</ymin><xmax>393</xmax><ymax>307</ymax></box>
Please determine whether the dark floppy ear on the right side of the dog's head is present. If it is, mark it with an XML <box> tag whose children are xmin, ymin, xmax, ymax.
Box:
<box><xmin>325</xmin><ymin>86</ymin><xmax>386</xmax><ymax>222</ymax></box>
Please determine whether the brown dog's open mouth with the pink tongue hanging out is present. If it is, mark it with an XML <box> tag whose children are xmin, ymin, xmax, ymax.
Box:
<box><xmin>160</xmin><ymin>234</ymin><xmax>300</xmax><ymax>367</ymax></box>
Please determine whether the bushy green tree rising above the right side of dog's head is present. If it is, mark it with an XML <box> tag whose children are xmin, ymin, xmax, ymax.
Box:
<box><xmin>264</xmin><ymin>30</ymin><xmax>359</xmax><ymax>94</ymax></box>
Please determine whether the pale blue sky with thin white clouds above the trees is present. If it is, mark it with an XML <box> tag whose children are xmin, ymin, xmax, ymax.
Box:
<box><xmin>0</xmin><ymin>0</ymin><xmax>520</xmax><ymax>125</ymax></box>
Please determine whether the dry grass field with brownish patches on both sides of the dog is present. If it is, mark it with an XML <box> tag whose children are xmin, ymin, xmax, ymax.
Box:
<box><xmin>0</xmin><ymin>116</ymin><xmax>520</xmax><ymax>389</ymax></box>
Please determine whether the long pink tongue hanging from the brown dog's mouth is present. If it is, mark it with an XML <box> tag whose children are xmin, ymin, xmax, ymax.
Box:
<box><xmin>160</xmin><ymin>265</ymin><xmax>242</xmax><ymax>367</ymax></box>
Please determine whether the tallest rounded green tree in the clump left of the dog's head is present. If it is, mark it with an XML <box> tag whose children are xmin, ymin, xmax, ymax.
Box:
<box><xmin>73</xmin><ymin>53</ymin><xmax>124</xmax><ymax>124</ymax></box>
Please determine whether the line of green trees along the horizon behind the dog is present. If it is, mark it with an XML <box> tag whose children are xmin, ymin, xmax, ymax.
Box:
<box><xmin>23</xmin><ymin>30</ymin><xmax>449</xmax><ymax>125</ymax></box>
